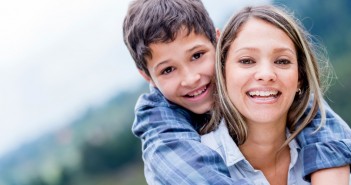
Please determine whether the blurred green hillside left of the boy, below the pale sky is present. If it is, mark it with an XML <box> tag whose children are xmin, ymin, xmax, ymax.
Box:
<box><xmin>0</xmin><ymin>86</ymin><xmax>146</xmax><ymax>185</ymax></box>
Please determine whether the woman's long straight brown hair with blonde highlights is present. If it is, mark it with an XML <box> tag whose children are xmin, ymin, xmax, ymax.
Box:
<box><xmin>202</xmin><ymin>5</ymin><xmax>332</xmax><ymax>146</ymax></box>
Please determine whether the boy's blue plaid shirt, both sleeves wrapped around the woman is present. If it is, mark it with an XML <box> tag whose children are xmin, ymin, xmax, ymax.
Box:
<box><xmin>132</xmin><ymin>86</ymin><xmax>351</xmax><ymax>185</ymax></box>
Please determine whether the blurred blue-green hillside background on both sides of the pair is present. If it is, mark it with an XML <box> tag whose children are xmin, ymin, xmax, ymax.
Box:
<box><xmin>0</xmin><ymin>0</ymin><xmax>351</xmax><ymax>185</ymax></box>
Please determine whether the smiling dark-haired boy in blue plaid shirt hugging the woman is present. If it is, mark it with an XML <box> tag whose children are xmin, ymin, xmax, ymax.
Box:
<box><xmin>123</xmin><ymin>0</ymin><xmax>351</xmax><ymax>184</ymax></box>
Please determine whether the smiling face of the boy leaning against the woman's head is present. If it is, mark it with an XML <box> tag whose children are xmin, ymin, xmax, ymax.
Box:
<box><xmin>141</xmin><ymin>30</ymin><xmax>215</xmax><ymax>114</ymax></box>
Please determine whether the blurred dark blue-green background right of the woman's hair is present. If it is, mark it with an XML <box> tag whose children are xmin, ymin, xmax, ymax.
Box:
<box><xmin>274</xmin><ymin>0</ymin><xmax>351</xmax><ymax>125</ymax></box>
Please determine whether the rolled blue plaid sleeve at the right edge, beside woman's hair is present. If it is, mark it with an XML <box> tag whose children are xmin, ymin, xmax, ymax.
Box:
<box><xmin>297</xmin><ymin>99</ymin><xmax>351</xmax><ymax>181</ymax></box>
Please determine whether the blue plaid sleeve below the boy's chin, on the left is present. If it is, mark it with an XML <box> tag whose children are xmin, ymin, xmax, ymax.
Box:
<box><xmin>132</xmin><ymin>107</ymin><xmax>253</xmax><ymax>185</ymax></box>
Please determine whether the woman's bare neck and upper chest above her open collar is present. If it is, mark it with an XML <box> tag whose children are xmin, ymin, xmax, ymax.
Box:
<box><xmin>239</xmin><ymin>122</ymin><xmax>290</xmax><ymax>184</ymax></box>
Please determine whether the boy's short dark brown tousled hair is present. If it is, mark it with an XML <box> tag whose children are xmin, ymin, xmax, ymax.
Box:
<box><xmin>123</xmin><ymin>0</ymin><xmax>216</xmax><ymax>76</ymax></box>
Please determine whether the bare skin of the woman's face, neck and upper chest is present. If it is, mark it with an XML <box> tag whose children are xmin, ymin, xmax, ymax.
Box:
<box><xmin>225</xmin><ymin>18</ymin><xmax>299</xmax><ymax>184</ymax></box>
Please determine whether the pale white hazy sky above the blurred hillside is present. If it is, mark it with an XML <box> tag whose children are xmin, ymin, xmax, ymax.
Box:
<box><xmin>0</xmin><ymin>0</ymin><xmax>268</xmax><ymax>157</ymax></box>
